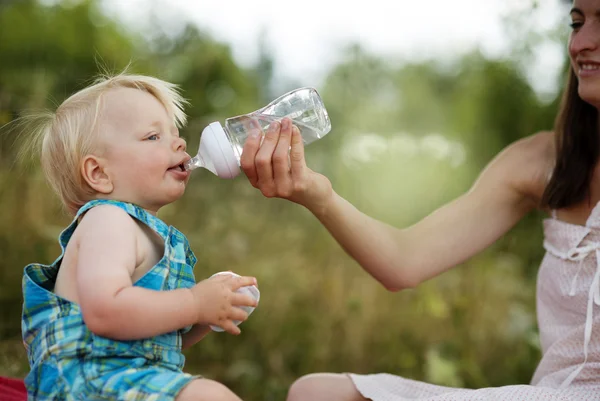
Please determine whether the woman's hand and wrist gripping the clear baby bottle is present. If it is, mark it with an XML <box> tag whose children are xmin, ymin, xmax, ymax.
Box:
<box><xmin>240</xmin><ymin>118</ymin><xmax>333</xmax><ymax>215</ymax></box>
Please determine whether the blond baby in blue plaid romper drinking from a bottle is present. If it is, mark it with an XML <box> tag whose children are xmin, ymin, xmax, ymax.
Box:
<box><xmin>22</xmin><ymin>74</ymin><xmax>257</xmax><ymax>401</ymax></box>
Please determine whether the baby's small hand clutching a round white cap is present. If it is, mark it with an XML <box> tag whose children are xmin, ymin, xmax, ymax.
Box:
<box><xmin>191</xmin><ymin>274</ymin><xmax>258</xmax><ymax>335</ymax></box>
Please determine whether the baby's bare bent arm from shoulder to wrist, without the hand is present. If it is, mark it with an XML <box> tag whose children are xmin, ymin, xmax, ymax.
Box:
<box><xmin>76</xmin><ymin>205</ymin><xmax>199</xmax><ymax>340</ymax></box>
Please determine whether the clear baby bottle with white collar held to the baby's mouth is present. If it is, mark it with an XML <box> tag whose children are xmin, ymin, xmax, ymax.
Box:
<box><xmin>185</xmin><ymin>88</ymin><xmax>331</xmax><ymax>178</ymax></box>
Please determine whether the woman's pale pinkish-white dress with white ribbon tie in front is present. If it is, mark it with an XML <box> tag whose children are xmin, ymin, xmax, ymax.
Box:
<box><xmin>349</xmin><ymin>208</ymin><xmax>600</xmax><ymax>401</ymax></box>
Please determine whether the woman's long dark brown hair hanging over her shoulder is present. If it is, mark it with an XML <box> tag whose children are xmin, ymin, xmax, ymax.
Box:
<box><xmin>542</xmin><ymin>67</ymin><xmax>600</xmax><ymax>209</ymax></box>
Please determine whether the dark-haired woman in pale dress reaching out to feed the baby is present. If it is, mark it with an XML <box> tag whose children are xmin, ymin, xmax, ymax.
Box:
<box><xmin>241</xmin><ymin>0</ymin><xmax>600</xmax><ymax>401</ymax></box>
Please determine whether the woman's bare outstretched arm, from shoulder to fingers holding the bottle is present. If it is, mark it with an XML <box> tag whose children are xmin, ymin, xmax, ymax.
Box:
<box><xmin>241</xmin><ymin>121</ymin><xmax>552</xmax><ymax>290</ymax></box>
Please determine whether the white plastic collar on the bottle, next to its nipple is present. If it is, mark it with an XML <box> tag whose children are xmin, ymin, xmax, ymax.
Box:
<box><xmin>200</xmin><ymin>121</ymin><xmax>240</xmax><ymax>178</ymax></box>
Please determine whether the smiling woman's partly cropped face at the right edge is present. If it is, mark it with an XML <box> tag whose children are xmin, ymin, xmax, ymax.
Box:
<box><xmin>569</xmin><ymin>0</ymin><xmax>600</xmax><ymax>108</ymax></box>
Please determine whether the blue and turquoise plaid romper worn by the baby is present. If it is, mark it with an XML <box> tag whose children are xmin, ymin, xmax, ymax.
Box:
<box><xmin>21</xmin><ymin>200</ymin><xmax>196</xmax><ymax>401</ymax></box>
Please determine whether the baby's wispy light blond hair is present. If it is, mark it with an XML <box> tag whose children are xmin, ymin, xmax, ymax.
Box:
<box><xmin>18</xmin><ymin>73</ymin><xmax>187</xmax><ymax>214</ymax></box>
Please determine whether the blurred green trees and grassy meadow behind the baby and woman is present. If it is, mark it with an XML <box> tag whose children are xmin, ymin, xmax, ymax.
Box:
<box><xmin>0</xmin><ymin>0</ymin><xmax>569</xmax><ymax>401</ymax></box>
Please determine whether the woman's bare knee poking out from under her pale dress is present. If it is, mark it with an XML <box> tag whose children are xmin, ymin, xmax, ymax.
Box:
<box><xmin>287</xmin><ymin>373</ymin><xmax>366</xmax><ymax>401</ymax></box>
